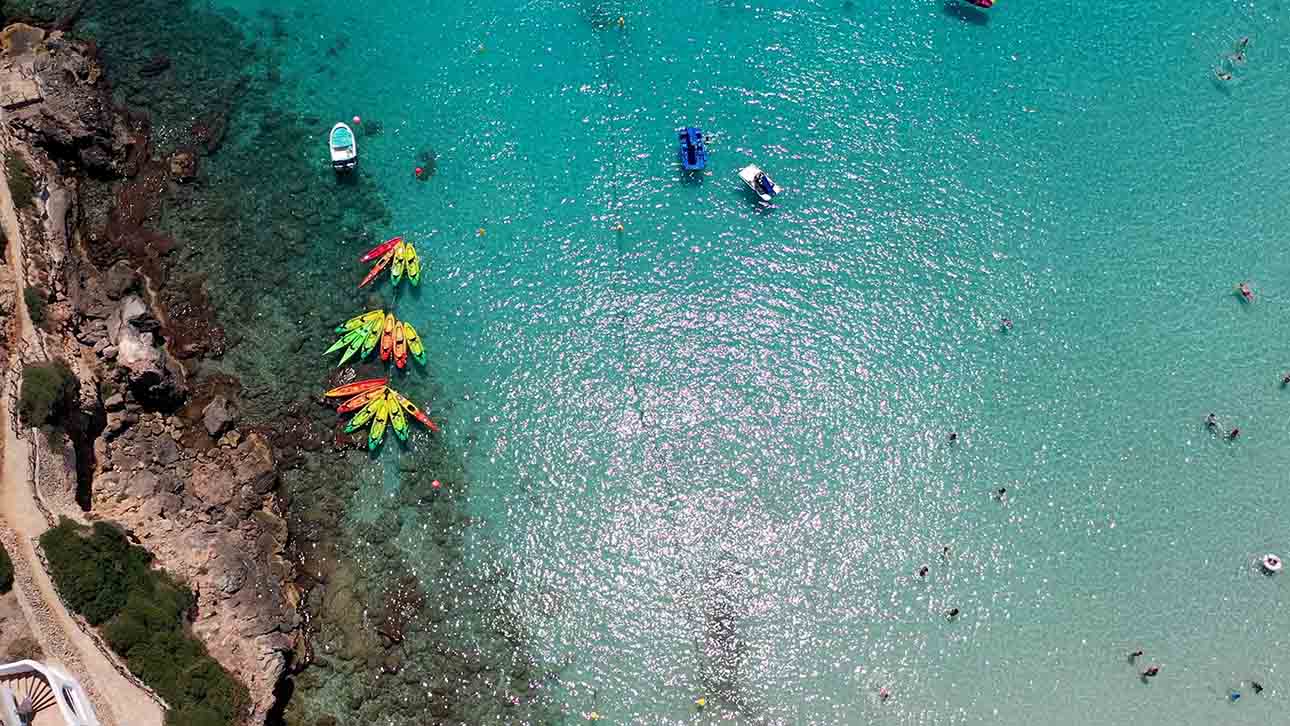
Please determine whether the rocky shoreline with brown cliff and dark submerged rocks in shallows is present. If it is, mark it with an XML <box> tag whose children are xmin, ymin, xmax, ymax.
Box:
<box><xmin>0</xmin><ymin>0</ymin><xmax>559</xmax><ymax>726</ymax></box>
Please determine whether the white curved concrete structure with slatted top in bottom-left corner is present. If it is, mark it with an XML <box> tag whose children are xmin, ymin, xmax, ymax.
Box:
<box><xmin>0</xmin><ymin>660</ymin><xmax>99</xmax><ymax>726</ymax></box>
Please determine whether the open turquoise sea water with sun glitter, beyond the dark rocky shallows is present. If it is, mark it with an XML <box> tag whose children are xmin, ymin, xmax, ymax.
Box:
<box><xmin>203</xmin><ymin>0</ymin><xmax>1290</xmax><ymax>725</ymax></box>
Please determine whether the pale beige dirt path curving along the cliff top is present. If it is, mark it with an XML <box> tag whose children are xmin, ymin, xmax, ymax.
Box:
<box><xmin>0</xmin><ymin>150</ymin><xmax>165</xmax><ymax>726</ymax></box>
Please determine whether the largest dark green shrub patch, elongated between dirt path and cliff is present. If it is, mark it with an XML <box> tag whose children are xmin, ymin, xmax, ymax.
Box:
<box><xmin>40</xmin><ymin>518</ymin><xmax>249</xmax><ymax>726</ymax></box>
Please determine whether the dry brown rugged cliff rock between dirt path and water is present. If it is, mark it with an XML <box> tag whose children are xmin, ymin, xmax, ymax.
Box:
<box><xmin>0</xmin><ymin>25</ymin><xmax>299</xmax><ymax>723</ymax></box>
